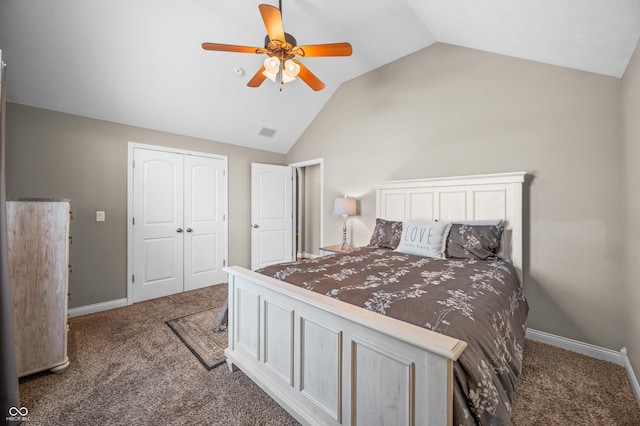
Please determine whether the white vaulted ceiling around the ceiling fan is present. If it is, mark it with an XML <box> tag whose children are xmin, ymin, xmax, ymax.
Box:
<box><xmin>0</xmin><ymin>0</ymin><xmax>640</xmax><ymax>153</ymax></box>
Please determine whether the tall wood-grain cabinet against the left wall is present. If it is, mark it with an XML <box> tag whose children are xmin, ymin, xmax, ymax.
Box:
<box><xmin>7</xmin><ymin>199</ymin><xmax>70</xmax><ymax>377</ymax></box>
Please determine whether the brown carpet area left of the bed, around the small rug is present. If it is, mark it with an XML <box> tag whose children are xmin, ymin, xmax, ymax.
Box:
<box><xmin>20</xmin><ymin>285</ymin><xmax>297</xmax><ymax>426</ymax></box>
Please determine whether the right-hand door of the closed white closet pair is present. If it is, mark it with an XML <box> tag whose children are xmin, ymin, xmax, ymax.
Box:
<box><xmin>184</xmin><ymin>155</ymin><xmax>227</xmax><ymax>291</ymax></box>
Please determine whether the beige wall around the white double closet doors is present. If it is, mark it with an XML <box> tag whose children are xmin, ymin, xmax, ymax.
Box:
<box><xmin>6</xmin><ymin>103</ymin><xmax>284</xmax><ymax>308</ymax></box>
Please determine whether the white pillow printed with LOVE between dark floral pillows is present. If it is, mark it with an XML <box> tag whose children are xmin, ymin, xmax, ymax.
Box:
<box><xmin>395</xmin><ymin>220</ymin><xmax>451</xmax><ymax>259</ymax></box>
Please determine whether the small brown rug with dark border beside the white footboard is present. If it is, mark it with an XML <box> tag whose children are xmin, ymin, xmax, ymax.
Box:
<box><xmin>167</xmin><ymin>306</ymin><xmax>228</xmax><ymax>370</ymax></box>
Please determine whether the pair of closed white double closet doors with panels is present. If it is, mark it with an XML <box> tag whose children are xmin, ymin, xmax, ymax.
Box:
<box><xmin>132</xmin><ymin>148</ymin><xmax>227</xmax><ymax>302</ymax></box>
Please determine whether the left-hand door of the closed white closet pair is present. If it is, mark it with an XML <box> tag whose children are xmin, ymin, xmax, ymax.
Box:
<box><xmin>133</xmin><ymin>149</ymin><xmax>184</xmax><ymax>302</ymax></box>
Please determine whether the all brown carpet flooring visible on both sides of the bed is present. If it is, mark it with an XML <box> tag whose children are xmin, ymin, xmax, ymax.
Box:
<box><xmin>20</xmin><ymin>285</ymin><xmax>640</xmax><ymax>426</ymax></box>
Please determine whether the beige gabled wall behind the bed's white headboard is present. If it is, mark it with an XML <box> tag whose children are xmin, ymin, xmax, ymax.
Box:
<box><xmin>287</xmin><ymin>44</ymin><xmax>627</xmax><ymax>350</ymax></box>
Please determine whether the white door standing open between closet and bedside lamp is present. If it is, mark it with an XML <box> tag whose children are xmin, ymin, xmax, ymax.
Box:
<box><xmin>251</xmin><ymin>163</ymin><xmax>293</xmax><ymax>270</ymax></box>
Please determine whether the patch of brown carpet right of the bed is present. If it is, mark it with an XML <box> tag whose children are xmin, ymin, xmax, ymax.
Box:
<box><xmin>511</xmin><ymin>340</ymin><xmax>640</xmax><ymax>426</ymax></box>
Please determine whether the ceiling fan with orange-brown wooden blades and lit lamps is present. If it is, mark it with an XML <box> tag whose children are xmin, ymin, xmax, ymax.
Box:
<box><xmin>202</xmin><ymin>1</ymin><xmax>352</xmax><ymax>91</ymax></box>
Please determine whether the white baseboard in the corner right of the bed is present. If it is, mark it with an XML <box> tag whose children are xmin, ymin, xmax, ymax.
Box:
<box><xmin>526</xmin><ymin>328</ymin><xmax>640</xmax><ymax>405</ymax></box>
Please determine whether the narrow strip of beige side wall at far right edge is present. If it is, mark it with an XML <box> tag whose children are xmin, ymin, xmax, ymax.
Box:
<box><xmin>622</xmin><ymin>43</ymin><xmax>640</xmax><ymax>384</ymax></box>
